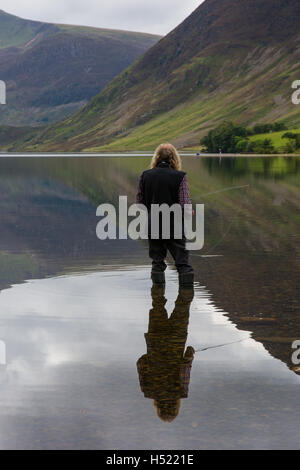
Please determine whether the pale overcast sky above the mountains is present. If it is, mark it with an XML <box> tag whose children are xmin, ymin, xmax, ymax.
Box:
<box><xmin>0</xmin><ymin>0</ymin><xmax>203</xmax><ymax>35</ymax></box>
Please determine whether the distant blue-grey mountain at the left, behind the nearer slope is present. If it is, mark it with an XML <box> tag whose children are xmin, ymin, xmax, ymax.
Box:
<box><xmin>0</xmin><ymin>10</ymin><xmax>159</xmax><ymax>126</ymax></box>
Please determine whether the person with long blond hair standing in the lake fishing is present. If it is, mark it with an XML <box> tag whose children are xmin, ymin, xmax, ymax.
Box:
<box><xmin>136</xmin><ymin>144</ymin><xmax>194</xmax><ymax>286</ymax></box>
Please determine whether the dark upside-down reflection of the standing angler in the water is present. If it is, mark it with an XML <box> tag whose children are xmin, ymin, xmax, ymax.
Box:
<box><xmin>137</xmin><ymin>286</ymin><xmax>195</xmax><ymax>422</ymax></box>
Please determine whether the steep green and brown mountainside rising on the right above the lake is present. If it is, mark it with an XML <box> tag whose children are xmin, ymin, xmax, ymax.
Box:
<box><xmin>18</xmin><ymin>0</ymin><xmax>300</xmax><ymax>151</ymax></box>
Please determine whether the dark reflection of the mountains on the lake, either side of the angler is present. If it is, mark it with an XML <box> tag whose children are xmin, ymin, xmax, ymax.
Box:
<box><xmin>0</xmin><ymin>157</ymin><xmax>300</xmax><ymax>380</ymax></box>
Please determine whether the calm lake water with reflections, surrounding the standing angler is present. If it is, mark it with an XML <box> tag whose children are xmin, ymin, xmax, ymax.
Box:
<box><xmin>0</xmin><ymin>156</ymin><xmax>300</xmax><ymax>450</ymax></box>
